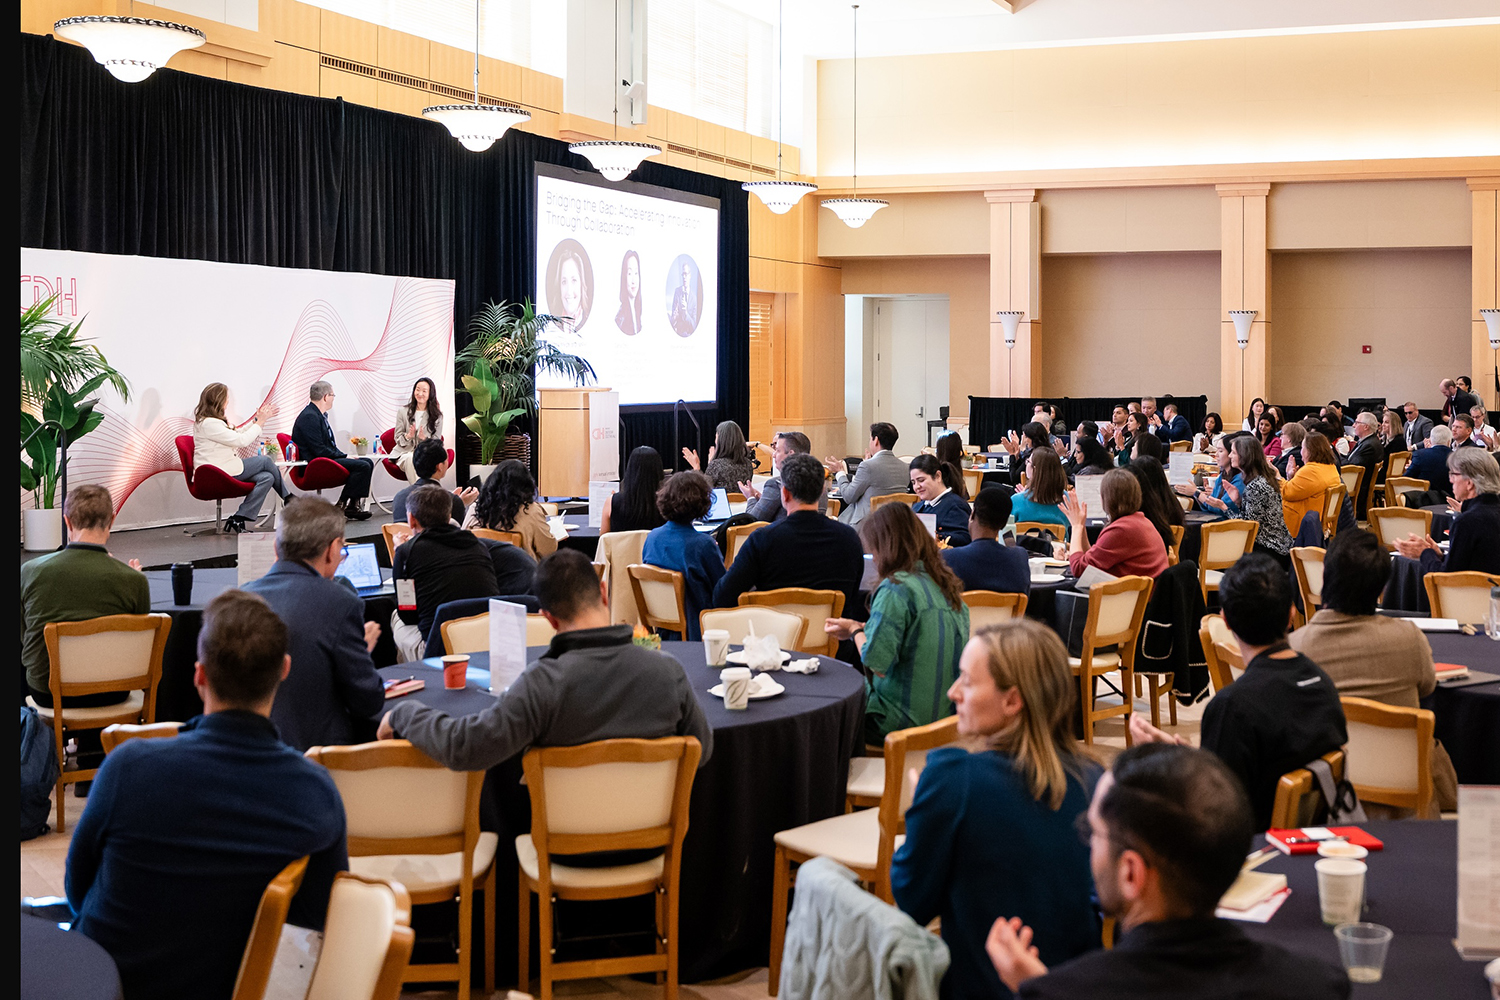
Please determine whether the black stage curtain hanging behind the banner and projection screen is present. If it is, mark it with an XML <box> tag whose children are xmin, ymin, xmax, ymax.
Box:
<box><xmin>20</xmin><ymin>34</ymin><xmax>750</xmax><ymax>479</ymax></box>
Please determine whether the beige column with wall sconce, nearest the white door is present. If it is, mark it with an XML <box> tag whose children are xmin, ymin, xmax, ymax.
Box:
<box><xmin>984</xmin><ymin>187</ymin><xmax>1043</xmax><ymax>396</ymax></box>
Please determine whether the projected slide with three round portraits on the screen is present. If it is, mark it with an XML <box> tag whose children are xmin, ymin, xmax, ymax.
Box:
<box><xmin>536</xmin><ymin>163</ymin><xmax>719</xmax><ymax>406</ymax></box>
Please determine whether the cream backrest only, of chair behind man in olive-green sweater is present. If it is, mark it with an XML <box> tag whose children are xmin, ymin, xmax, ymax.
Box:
<box><xmin>42</xmin><ymin>615</ymin><xmax>173</xmax><ymax>707</ymax></box>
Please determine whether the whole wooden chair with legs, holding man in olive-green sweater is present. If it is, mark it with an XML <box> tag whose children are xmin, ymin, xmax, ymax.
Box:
<box><xmin>26</xmin><ymin>615</ymin><xmax>173</xmax><ymax>834</ymax></box>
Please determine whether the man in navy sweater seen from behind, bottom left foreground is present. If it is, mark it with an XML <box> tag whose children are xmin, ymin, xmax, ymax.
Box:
<box><xmin>66</xmin><ymin>591</ymin><xmax>348</xmax><ymax>1000</ymax></box>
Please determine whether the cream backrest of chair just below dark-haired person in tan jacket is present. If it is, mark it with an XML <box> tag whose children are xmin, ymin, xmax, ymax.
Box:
<box><xmin>1340</xmin><ymin>697</ymin><xmax>1434</xmax><ymax>819</ymax></box>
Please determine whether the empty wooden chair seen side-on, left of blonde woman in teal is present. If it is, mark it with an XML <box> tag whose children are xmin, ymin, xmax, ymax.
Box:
<box><xmin>767</xmin><ymin>715</ymin><xmax>959</xmax><ymax>997</ymax></box>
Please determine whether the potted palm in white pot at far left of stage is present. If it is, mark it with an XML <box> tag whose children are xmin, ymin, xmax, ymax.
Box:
<box><xmin>21</xmin><ymin>295</ymin><xmax>131</xmax><ymax>552</ymax></box>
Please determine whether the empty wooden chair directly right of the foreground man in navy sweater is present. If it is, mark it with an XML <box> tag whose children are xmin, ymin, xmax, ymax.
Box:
<box><xmin>306</xmin><ymin>739</ymin><xmax>500</xmax><ymax>1000</ymax></box>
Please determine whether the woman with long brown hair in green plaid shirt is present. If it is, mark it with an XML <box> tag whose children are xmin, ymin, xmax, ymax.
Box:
<box><xmin>824</xmin><ymin>504</ymin><xmax>969</xmax><ymax>744</ymax></box>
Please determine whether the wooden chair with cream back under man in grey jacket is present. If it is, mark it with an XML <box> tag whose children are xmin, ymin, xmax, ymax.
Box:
<box><xmin>516</xmin><ymin>736</ymin><xmax>702</xmax><ymax>1000</ymax></box>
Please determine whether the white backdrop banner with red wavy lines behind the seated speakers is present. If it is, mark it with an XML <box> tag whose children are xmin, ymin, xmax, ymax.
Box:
<box><xmin>21</xmin><ymin>247</ymin><xmax>456</xmax><ymax>528</ymax></box>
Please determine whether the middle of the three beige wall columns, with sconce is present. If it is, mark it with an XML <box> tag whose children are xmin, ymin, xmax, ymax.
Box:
<box><xmin>1209</xmin><ymin>184</ymin><xmax>1271</xmax><ymax>427</ymax></box>
